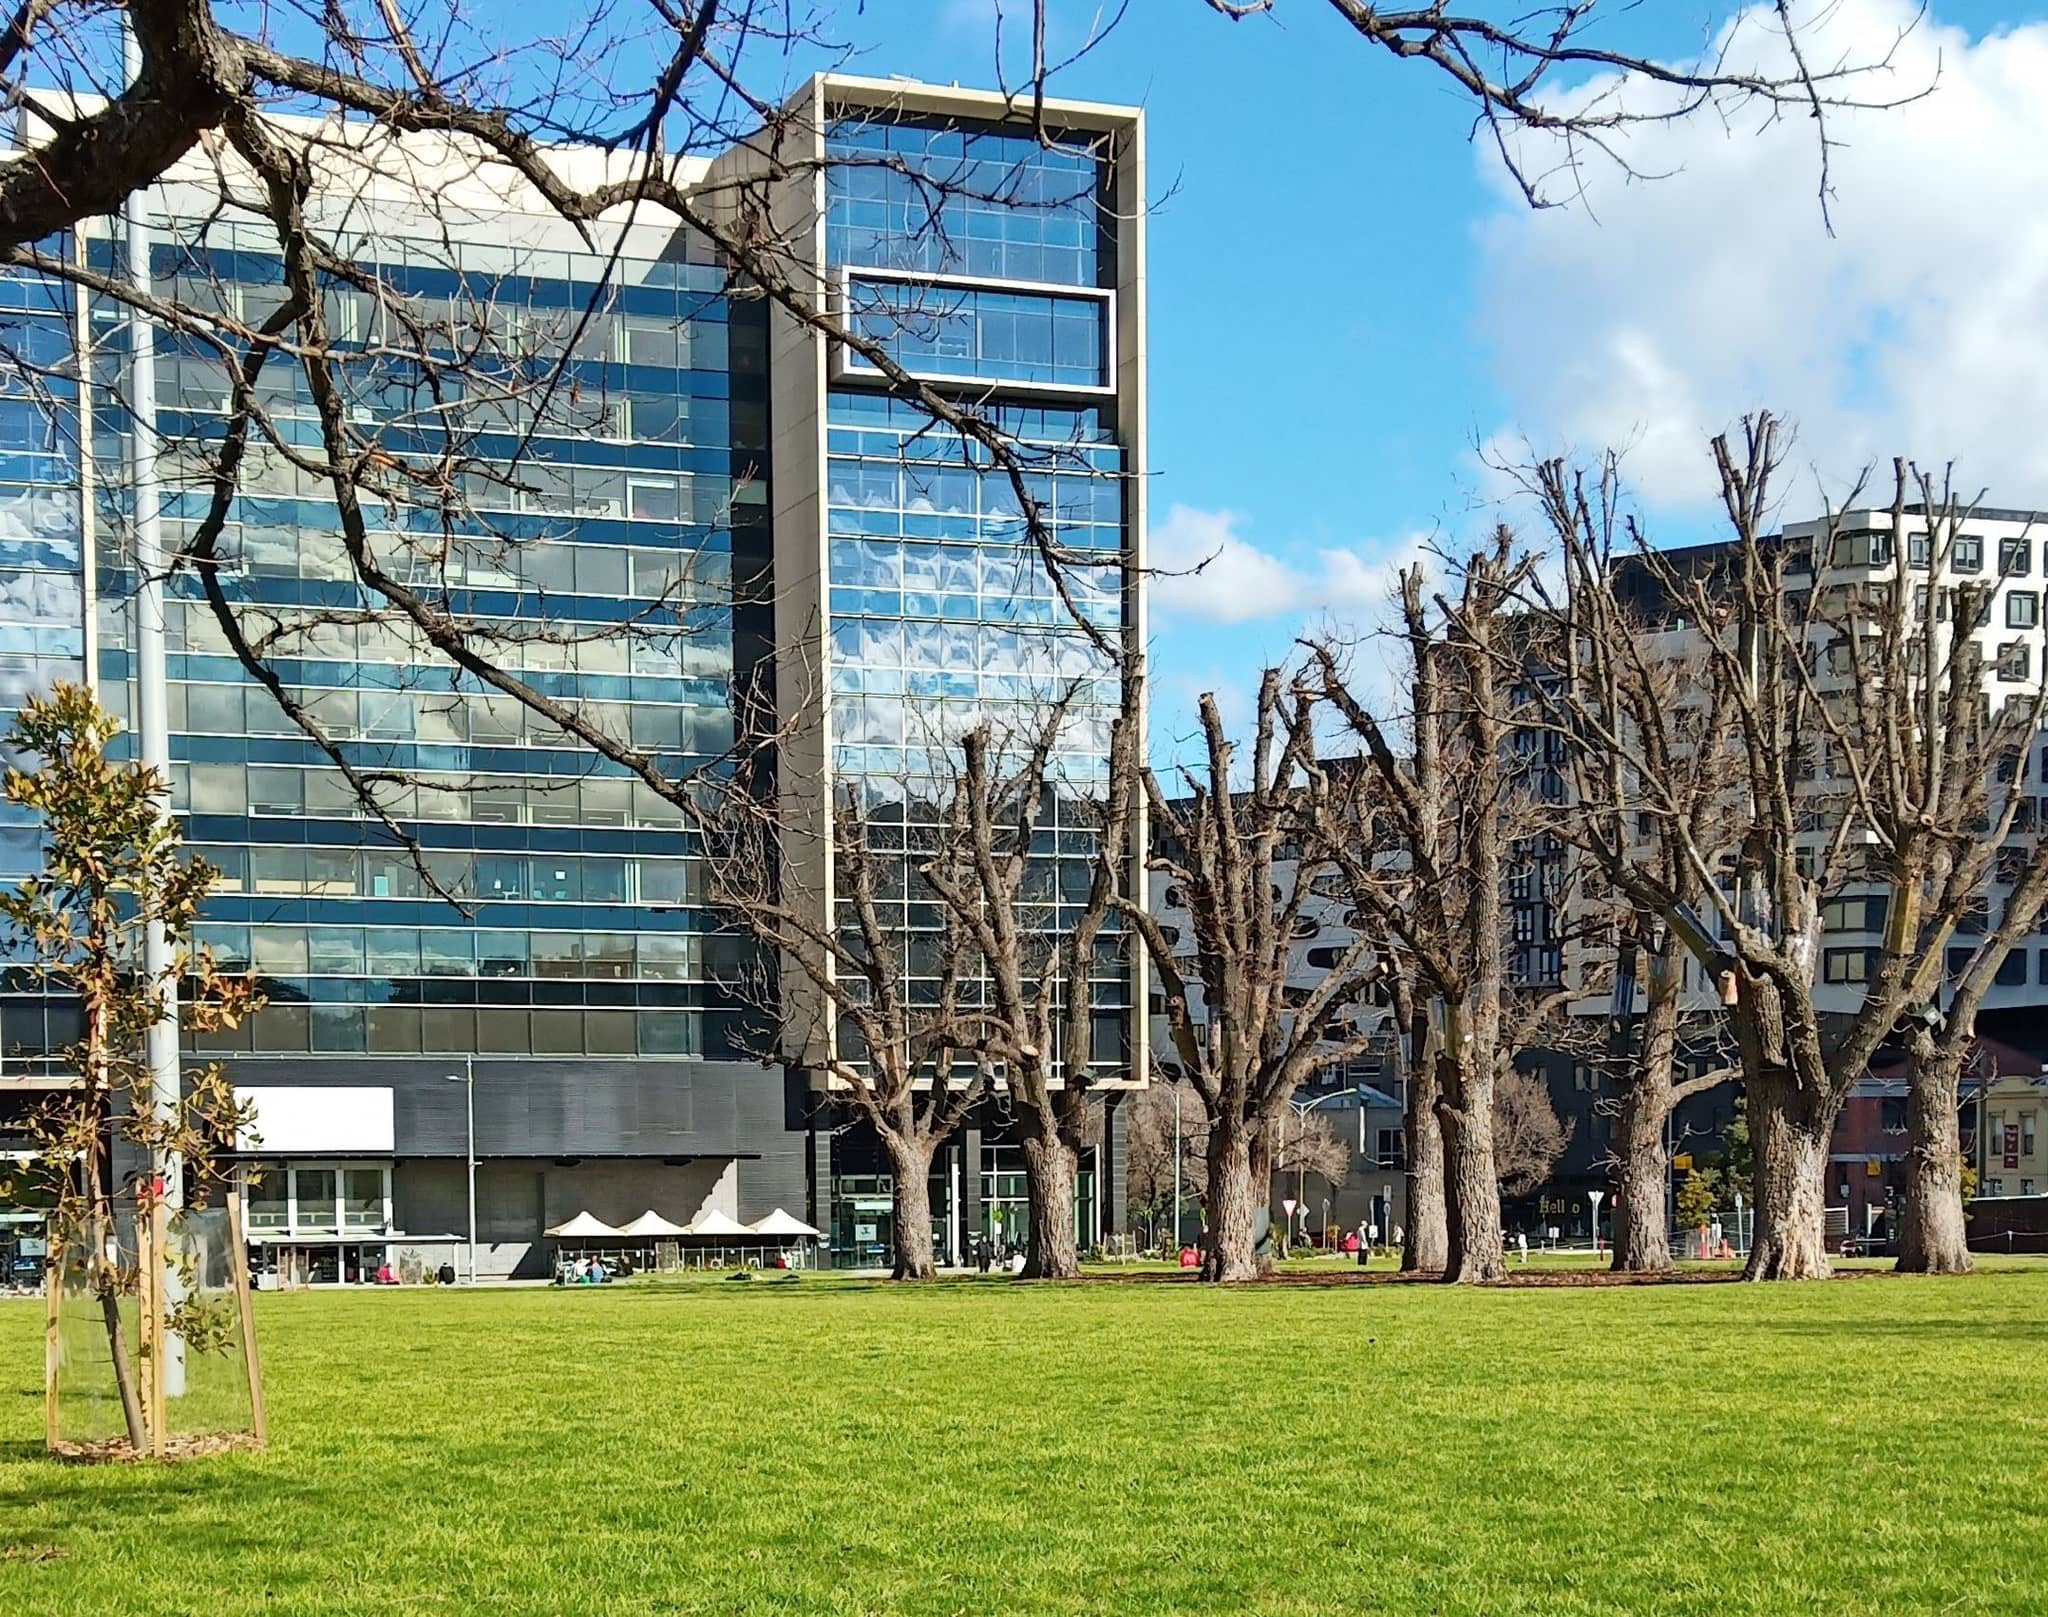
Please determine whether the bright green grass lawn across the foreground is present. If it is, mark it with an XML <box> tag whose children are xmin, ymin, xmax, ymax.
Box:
<box><xmin>0</xmin><ymin>1265</ymin><xmax>2048</xmax><ymax>1617</ymax></box>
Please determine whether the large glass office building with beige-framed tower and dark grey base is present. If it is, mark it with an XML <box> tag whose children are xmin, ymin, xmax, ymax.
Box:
<box><xmin>0</xmin><ymin>80</ymin><xmax>1141</xmax><ymax>1279</ymax></box>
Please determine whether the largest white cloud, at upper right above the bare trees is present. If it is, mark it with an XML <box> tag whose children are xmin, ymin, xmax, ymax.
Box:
<box><xmin>1481</xmin><ymin>0</ymin><xmax>2048</xmax><ymax>506</ymax></box>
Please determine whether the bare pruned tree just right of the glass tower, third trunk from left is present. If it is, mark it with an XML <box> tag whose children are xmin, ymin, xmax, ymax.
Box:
<box><xmin>1118</xmin><ymin>669</ymin><xmax>1378</xmax><ymax>1281</ymax></box>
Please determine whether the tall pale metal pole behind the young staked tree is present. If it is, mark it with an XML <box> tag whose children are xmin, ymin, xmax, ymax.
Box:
<box><xmin>121</xmin><ymin>14</ymin><xmax>184</xmax><ymax>1398</ymax></box>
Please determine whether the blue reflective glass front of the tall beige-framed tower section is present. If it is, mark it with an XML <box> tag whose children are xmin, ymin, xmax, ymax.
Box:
<box><xmin>825</xmin><ymin>117</ymin><xmax>1130</xmax><ymax>1066</ymax></box>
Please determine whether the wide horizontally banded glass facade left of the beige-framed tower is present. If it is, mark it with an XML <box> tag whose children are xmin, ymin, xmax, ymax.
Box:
<box><xmin>74</xmin><ymin>223</ymin><xmax>768</xmax><ymax>1056</ymax></box>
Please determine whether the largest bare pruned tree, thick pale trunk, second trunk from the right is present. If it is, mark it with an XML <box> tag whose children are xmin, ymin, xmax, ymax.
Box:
<box><xmin>1548</xmin><ymin>418</ymin><xmax>2048</xmax><ymax>1279</ymax></box>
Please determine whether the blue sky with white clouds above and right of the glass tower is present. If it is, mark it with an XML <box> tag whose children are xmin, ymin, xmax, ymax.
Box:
<box><xmin>761</xmin><ymin>0</ymin><xmax>2048</xmax><ymax>739</ymax></box>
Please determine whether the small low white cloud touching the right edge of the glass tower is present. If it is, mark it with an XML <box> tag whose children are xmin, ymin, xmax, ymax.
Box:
<box><xmin>1147</xmin><ymin>506</ymin><xmax>1423</xmax><ymax>624</ymax></box>
